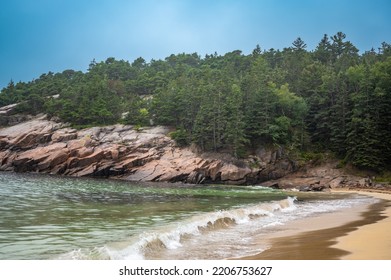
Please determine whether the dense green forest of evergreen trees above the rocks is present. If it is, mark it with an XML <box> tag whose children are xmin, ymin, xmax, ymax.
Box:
<box><xmin>0</xmin><ymin>32</ymin><xmax>391</xmax><ymax>171</ymax></box>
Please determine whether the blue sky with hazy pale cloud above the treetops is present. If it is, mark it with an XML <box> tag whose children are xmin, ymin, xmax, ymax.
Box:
<box><xmin>0</xmin><ymin>0</ymin><xmax>391</xmax><ymax>88</ymax></box>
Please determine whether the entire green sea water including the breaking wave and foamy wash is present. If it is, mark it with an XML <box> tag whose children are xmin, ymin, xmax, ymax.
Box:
<box><xmin>0</xmin><ymin>172</ymin><xmax>377</xmax><ymax>260</ymax></box>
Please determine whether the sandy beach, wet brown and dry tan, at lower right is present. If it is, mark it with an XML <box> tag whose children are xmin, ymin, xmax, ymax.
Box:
<box><xmin>241</xmin><ymin>192</ymin><xmax>391</xmax><ymax>260</ymax></box>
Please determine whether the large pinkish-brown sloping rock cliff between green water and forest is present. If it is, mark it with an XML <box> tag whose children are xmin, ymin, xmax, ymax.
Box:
<box><xmin>0</xmin><ymin>116</ymin><xmax>296</xmax><ymax>184</ymax></box>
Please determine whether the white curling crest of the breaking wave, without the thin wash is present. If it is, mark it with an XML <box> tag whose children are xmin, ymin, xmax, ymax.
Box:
<box><xmin>60</xmin><ymin>197</ymin><xmax>296</xmax><ymax>259</ymax></box>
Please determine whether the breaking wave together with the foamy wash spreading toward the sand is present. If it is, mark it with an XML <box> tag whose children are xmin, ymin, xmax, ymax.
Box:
<box><xmin>56</xmin><ymin>197</ymin><xmax>374</xmax><ymax>260</ymax></box>
